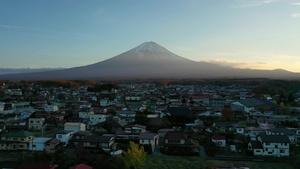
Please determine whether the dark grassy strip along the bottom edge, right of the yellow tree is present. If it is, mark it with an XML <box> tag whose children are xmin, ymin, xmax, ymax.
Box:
<box><xmin>143</xmin><ymin>156</ymin><xmax>296</xmax><ymax>169</ymax></box>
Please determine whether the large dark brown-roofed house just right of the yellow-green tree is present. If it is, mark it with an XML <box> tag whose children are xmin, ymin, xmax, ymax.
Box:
<box><xmin>161</xmin><ymin>131</ymin><xmax>200</xmax><ymax>155</ymax></box>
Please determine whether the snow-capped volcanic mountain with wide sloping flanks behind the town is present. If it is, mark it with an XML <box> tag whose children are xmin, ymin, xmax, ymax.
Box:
<box><xmin>0</xmin><ymin>42</ymin><xmax>300</xmax><ymax>80</ymax></box>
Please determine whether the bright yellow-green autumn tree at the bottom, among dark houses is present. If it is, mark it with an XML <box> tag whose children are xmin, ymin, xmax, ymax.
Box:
<box><xmin>123</xmin><ymin>141</ymin><xmax>147</xmax><ymax>169</ymax></box>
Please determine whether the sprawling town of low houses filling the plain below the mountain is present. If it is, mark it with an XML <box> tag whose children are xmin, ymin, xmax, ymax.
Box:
<box><xmin>0</xmin><ymin>79</ymin><xmax>300</xmax><ymax>169</ymax></box>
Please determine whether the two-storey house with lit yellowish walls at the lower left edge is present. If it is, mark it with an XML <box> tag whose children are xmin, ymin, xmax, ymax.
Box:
<box><xmin>0</xmin><ymin>130</ymin><xmax>34</xmax><ymax>150</ymax></box>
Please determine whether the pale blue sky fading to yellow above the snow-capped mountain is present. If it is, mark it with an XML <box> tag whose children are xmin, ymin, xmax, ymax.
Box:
<box><xmin>0</xmin><ymin>0</ymin><xmax>300</xmax><ymax>72</ymax></box>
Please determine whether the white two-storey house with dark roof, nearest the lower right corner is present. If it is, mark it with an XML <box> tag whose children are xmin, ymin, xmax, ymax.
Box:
<box><xmin>248</xmin><ymin>135</ymin><xmax>290</xmax><ymax>157</ymax></box>
